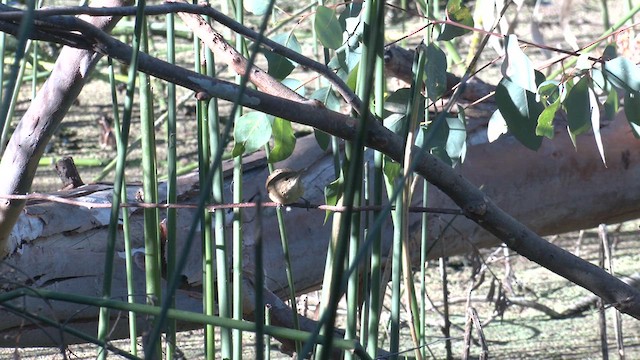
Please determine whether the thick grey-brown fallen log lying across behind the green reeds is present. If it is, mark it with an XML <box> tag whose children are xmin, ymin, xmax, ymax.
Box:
<box><xmin>0</xmin><ymin>110</ymin><xmax>640</xmax><ymax>346</ymax></box>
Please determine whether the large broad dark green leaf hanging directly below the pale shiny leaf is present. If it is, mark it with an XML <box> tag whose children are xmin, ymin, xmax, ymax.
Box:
<box><xmin>495</xmin><ymin>78</ymin><xmax>544</xmax><ymax>150</ymax></box>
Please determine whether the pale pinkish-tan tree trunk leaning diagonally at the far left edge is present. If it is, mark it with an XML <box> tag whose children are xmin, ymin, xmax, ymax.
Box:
<box><xmin>0</xmin><ymin>0</ymin><xmax>131</xmax><ymax>258</ymax></box>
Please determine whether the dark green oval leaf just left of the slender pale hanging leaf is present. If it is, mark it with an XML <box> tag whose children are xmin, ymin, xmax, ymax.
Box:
<box><xmin>564</xmin><ymin>76</ymin><xmax>598</xmax><ymax>136</ymax></box>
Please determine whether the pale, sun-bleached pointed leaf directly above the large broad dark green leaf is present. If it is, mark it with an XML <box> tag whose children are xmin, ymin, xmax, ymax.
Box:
<box><xmin>501</xmin><ymin>35</ymin><xmax>537</xmax><ymax>92</ymax></box>
